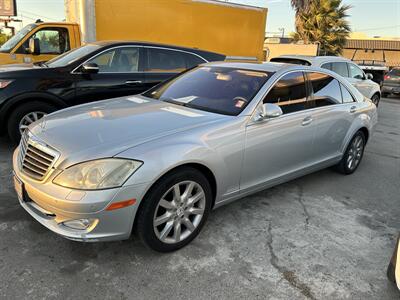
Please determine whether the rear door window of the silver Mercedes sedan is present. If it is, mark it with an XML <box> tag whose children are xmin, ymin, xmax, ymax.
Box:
<box><xmin>308</xmin><ymin>72</ymin><xmax>342</xmax><ymax>107</ymax></box>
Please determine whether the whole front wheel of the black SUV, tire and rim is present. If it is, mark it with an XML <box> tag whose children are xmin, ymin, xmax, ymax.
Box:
<box><xmin>7</xmin><ymin>101</ymin><xmax>57</xmax><ymax>143</ymax></box>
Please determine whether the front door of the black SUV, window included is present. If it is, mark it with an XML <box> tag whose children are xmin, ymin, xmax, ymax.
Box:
<box><xmin>74</xmin><ymin>46</ymin><xmax>146</xmax><ymax>103</ymax></box>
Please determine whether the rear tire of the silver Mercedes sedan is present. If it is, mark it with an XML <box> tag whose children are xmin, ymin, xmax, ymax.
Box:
<box><xmin>335</xmin><ymin>131</ymin><xmax>366</xmax><ymax>175</ymax></box>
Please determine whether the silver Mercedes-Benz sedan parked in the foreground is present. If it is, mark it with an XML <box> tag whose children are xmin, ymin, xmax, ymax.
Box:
<box><xmin>13</xmin><ymin>63</ymin><xmax>377</xmax><ymax>251</ymax></box>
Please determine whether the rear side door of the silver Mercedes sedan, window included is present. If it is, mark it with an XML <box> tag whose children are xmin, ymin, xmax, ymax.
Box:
<box><xmin>306</xmin><ymin>72</ymin><xmax>356</xmax><ymax>162</ymax></box>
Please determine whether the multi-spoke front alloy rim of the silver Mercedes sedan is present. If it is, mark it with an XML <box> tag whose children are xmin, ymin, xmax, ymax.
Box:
<box><xmin>153</xmin><ymin>181</ymin><xmax>206</xmax><ymax>244</ymax></box>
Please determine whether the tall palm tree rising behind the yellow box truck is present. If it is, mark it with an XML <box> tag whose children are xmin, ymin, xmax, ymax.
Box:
<box><xmin>293</xmin><ymin>0</ymin><xmax>351</xmax><ymax>55</ymax></box>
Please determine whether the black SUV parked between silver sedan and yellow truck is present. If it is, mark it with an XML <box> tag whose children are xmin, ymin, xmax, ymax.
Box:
<box><xmin>0</xmin><ymin>41</ymin><xmax>225</xmax><ymax>142</ymax></box>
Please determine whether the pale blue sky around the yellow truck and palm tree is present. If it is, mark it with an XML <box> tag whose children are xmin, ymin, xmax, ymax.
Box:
<box><xmin>10</xmin><ymin>0</ymin><xmax>400</xmax><ymax>37</ymax></box>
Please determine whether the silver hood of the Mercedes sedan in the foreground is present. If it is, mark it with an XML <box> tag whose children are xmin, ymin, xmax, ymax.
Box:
<box><xmin>29</xmin><ymin>96</ymin><xmax>227</xmax><ymax>163</ymax></box>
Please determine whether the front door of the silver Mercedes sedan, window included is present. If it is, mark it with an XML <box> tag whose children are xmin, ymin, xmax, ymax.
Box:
<box><xmin>240</xmin><ymin>72</ymin><xmax>315</xmax><ymax>191</ymax></box>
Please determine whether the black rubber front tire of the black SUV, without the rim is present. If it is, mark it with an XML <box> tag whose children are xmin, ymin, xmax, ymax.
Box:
<box><xmin>7</xmin><ymin>101</ymin><xmax>57</xmax><ymax>144</ymax></box>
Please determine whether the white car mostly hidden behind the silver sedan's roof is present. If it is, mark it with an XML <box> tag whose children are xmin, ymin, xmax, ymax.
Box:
<box><xmin>271</xmin><ymin>55</ymin><xmax>381</xmax><ymax>106</ymax></box>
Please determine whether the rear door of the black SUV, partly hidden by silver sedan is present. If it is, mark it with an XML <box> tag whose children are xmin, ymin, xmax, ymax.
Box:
<box><xmin>144</xmin><ymin>47</ymin><xmax>207</xmax><ymax>89</ymax></box>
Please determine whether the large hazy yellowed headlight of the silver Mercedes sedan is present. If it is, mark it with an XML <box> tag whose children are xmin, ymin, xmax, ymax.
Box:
<box><xmin>53</xmin><ymin>158</ymin><xmax>143</xmax><ymax>190</ymax></box>
